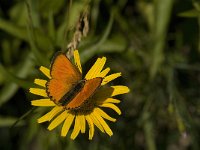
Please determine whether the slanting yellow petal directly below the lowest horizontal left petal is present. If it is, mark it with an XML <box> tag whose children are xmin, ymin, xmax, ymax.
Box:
<box><xmin>37</xmin><ymin>106</ymin><xmax>63</xmax><ymax>123</ymax></box>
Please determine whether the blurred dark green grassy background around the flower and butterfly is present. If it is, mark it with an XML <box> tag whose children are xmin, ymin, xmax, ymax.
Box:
<box><xmin>0</xmin><ymin>0</ymin><xmax>200</xmax><ymax>150</ymax></box>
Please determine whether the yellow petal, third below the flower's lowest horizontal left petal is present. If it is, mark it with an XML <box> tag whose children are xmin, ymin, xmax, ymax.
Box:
<box><xmin>61</xmin><ymin>113</ymin><xmax>74</xmax><ymax>136</ymax></box>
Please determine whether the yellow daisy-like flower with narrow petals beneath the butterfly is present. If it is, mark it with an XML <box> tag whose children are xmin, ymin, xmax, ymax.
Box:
<box><xmin>30</xmin><ymin>50</ymin><xmax>129</xmax><ymax>140</ymax></box>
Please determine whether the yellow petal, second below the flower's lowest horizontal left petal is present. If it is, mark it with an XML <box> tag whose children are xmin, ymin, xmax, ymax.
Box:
<box><xmin>48</xmin><ymin>111</ymin><xmax>67</xmax><ymax>130</ymax></box>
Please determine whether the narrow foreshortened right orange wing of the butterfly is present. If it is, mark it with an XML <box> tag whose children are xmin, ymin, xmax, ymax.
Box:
<box><xmin>66</xmin><ymin>77</ymin><xmax>102</xmax><ymax>109</ymax></box>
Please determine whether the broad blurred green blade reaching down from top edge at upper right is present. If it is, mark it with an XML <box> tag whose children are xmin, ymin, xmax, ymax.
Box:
<box><xmin>150</xmin><ymin>0</ymin><xmax>174</xmax><ymax>78</ymax></box>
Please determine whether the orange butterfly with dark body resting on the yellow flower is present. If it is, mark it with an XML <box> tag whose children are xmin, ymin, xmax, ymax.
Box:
<box><xmin>46</xmin><ymin>52</ymin><xmax>103</xmax><ymax>110</ymax></box>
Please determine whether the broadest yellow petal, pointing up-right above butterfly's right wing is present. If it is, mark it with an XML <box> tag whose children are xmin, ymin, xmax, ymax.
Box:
<box><xmin>85</xmin><ymin>57</ymin><xmax>106</xmax><ymax>80</ymax></box>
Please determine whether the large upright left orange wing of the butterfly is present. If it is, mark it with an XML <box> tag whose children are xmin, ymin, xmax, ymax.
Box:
<box><xmin>47</xmin><ymin>52</ymin><xmax>81</xmax><ymax>102</ymax></box>
